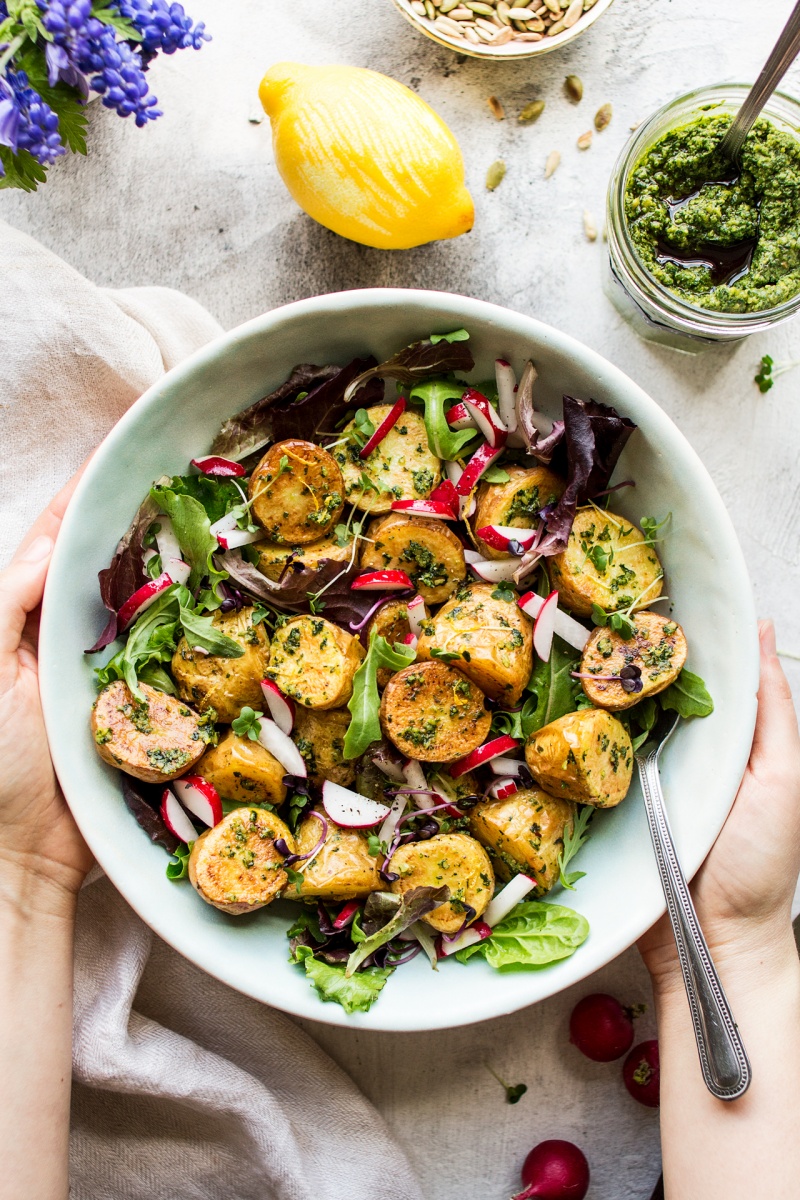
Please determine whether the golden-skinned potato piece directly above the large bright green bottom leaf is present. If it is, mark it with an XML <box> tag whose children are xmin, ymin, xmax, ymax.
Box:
<box><xmin>469</xmin><ymin>787</ymin><xmax>576</xmax><ymax>895</ymax></box>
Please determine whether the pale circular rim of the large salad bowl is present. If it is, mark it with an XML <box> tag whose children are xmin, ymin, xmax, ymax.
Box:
<box><xmin>40</xmin><ymin>288</ymin><xmax>759</xmax><ymax>1032</ymax></box>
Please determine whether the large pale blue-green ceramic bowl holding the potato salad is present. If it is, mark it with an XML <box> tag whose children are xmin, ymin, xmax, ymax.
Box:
<box><xmin>41</xmin><ymin>289</ymin><xmax>758</xmax><ymax>1030</ymax></box>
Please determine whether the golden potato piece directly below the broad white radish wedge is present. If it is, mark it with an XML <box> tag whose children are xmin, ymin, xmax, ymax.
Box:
<box><xmin>293</xmin><ymin>816</ymin><xmax>384</xmax><ymax>900</ymax></box>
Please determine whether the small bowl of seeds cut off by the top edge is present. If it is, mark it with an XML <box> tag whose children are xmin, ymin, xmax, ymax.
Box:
<box><xmin>392</xmin><ymin>0</ymin><xmax>613</xmax><ymax>59</ymax></box>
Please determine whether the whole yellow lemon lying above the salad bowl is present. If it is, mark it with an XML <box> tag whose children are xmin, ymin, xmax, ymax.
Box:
<box><xmin>259</xmin><ymin>62</ymin><xmax>475</xmax><ymax>250</ymax></box>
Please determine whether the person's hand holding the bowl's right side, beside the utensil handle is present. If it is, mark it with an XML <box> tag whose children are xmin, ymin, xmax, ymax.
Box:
<box><xmin>638</xmin><ymin>620</ymin><xmax>800</xmax><ymax>986</ymax></box>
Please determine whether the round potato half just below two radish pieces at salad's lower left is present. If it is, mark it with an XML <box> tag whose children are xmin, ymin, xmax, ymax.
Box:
<box><xmin>188</xmin><ymin>808</ymin><xmax>294</xmax><ymax>917</ymax></box>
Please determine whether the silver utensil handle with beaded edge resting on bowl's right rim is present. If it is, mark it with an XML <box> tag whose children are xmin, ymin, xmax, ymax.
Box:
<box><xmin>638</xmin><ymin>752</ymin><xmax>752</xmax><ymax>1100</ymax></box>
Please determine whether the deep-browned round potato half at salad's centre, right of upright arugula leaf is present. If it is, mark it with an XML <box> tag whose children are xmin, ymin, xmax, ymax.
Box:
<box><xmin>380</xmin><ymin>661</ymin><xmax>492</xmax><ymax>762</ymax></box>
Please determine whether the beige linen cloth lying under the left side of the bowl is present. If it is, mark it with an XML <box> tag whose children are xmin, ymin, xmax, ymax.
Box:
<box><xmin>0</xmin><ymin>222</ymin><xmax>421</xmax><ymax>1200</ymax></box>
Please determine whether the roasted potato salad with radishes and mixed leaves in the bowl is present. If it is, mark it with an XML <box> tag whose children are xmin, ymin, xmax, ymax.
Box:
<box><xmin>88</xmin><ymin>330</ymin><xmax>712</xmax><ymax>1013</ymax></box>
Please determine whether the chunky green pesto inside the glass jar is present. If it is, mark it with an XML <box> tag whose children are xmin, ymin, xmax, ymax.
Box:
<box><xmin>625</xmin><ymin>116</ymin><xmax>800</xmax><ymax>312</ymax></box>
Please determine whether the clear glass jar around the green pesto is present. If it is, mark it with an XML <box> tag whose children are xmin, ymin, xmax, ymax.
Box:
<box><xmin>606</xmin><ymin>83</ymin><xmax>800</xmax><ymax>353</ymax></box>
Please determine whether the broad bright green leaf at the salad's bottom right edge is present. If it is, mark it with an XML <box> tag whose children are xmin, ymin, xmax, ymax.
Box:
<box><xmin>456</xmin><ymin>900</ymin><xmax>589</xmax><ymax>971</ymax></box>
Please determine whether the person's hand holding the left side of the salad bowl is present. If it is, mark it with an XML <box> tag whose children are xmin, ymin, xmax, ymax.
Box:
<box><xmin>0</xmin><ymin>476</ymin><xmax>92</xmax><ymax>893</ymax></box>
